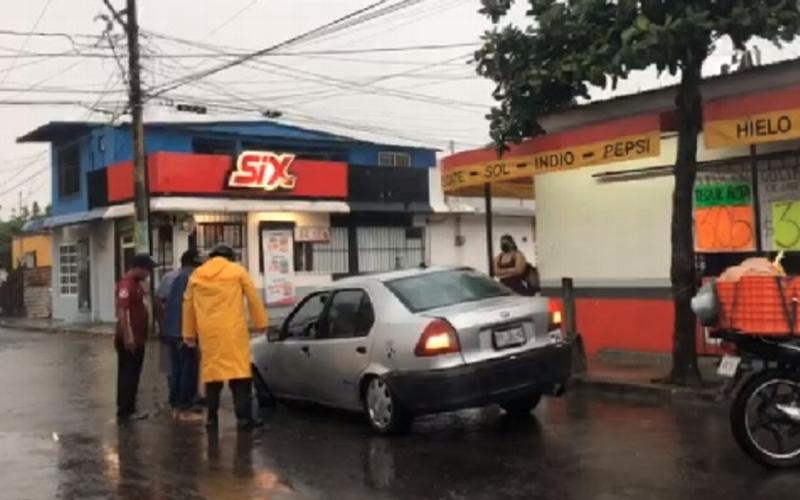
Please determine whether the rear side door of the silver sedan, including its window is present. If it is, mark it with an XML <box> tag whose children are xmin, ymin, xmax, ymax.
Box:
<box><xmin>311</xmin><ymin>289</ymin><xmax>375</xmax><ymax>409</ymax></box>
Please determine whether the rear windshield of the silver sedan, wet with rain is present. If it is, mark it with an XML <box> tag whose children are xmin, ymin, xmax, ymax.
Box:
<box><xmin>386</xmin><ymin>269</ymin><xmax>512</xmax><ymax>312</ymax></box>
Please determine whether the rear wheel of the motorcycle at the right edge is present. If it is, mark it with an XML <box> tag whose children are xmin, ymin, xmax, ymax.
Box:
<box><xmin>730</xmin><ymin>370</ymin><xmax>800</xmax><ymax>467</ymax></box>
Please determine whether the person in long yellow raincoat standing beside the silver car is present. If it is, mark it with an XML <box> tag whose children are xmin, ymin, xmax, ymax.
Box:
<box><xmin>182</xmin><ymin>245</ymin><xmax>269</xmax><ymax>429</ymax></box>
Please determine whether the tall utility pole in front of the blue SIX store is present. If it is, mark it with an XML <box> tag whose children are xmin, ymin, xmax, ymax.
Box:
<box><xmin>103</xmin><ymin>0</ymin><xmax>151</xmax><ymax>254</ymax></box>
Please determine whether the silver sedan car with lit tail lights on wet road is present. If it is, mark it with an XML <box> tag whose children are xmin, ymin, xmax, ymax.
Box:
<box><xmin>252</xmin><ymin>267</ymin><xmax>571</xmax><ymax>434</ymax></box>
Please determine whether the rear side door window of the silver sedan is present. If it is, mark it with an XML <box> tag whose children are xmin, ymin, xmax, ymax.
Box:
<box><xmin>321</xmin><ymin>290</ymin><xmax>375</xmax><ymax>338</ymax></box>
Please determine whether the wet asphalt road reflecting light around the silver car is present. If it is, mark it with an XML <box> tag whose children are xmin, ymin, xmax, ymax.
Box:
<box><xmin>0</xmin><ymin>330</ymin><xmax>800</xmax><ymax>500</ymax></box>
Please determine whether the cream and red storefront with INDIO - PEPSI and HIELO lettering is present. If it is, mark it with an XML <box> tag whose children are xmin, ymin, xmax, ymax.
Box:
<box><xmin>443</xmin><ymin>57</ymin><xmax>800</xmax><ymax>355</ymax></box>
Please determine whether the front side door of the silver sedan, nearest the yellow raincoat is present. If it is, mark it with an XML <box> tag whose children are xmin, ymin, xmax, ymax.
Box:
<box><xmin>267</xmin><ymin>292</ymin><xmax>330</xmax><ymax>400</ymax></box>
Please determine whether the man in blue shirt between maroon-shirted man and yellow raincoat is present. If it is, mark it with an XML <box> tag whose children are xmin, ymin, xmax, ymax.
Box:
<box><xmin>157</xmin><ymin>250</ymin><xmax>202</xmax><ymax>421</ymax></box>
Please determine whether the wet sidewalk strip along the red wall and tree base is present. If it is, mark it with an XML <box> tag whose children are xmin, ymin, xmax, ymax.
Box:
<box><xmin>571</xmin><ymin>351</ymin><xmax>724</xmax><ymax>401</ymax></box>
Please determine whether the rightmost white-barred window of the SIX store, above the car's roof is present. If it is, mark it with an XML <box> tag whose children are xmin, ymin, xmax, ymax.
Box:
<box><xmin>356</xmin><ymin>227</ymin><xmax>425</xmax><ymax>273</ymax></box>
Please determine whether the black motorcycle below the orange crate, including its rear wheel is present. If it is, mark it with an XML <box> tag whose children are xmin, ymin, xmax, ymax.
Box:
<box><xmin>714</xmin><ymin>331</ymin><xmax>800</xmax><ymax>467</ymax></box>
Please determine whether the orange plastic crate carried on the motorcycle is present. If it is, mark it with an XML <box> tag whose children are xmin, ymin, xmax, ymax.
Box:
<box><xmin>717</xmin><ymin>276</ymin><xmax>800</xmax><ymax>336</ymax></box>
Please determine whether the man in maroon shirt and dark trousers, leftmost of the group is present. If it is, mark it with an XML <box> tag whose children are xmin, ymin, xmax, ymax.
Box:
<box><xmin>114</xmin><ymin>254</ymin><xmax>155</xmax><ymax>420</ymax></box>
